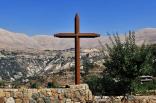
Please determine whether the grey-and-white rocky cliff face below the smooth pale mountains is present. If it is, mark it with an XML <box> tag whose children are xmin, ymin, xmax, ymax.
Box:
<box><xmin>0</xmin><ymin>49</ymin><xmax>102</xmax><ymax>81</ymax></box>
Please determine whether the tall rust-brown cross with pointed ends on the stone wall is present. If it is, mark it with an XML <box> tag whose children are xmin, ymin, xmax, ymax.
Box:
<box><xmin>54</xmin><ymin>14</ymin><xmax>100</xmax><ymax>84</ymax></box>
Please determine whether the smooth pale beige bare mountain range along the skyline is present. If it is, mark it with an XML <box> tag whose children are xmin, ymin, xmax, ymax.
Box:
<box><xmin>0</xmin><ymin>28</ymin><xmax>156</xmax><ymax>50</ymax></box>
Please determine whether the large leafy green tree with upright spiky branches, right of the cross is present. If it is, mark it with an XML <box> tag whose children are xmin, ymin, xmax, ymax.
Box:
<box><xmin>104</xmin><ymin>32</ymin><xmax>152</xmax><ymax>93</ymax></box>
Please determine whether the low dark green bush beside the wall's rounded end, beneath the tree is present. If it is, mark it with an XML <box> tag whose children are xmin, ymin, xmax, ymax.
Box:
<box><xmin>85</xmin><ymin>75</ymin><xmax>133</xmax><ymax>96</ymax></box>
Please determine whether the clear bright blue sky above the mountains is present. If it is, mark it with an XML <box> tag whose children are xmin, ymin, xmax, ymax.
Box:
<box><xmin>0</xmin><ymin>0</ymin><xmax>156</xmax><ymax>36</ymax></box>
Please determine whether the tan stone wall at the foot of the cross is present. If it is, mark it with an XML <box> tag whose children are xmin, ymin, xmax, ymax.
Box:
<box><xmin>0</xmin><ymin>84</ymin><xmax>92</xmax><ymax>103</ymax></box>
